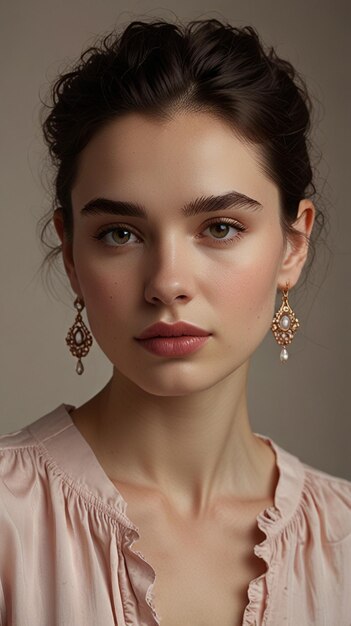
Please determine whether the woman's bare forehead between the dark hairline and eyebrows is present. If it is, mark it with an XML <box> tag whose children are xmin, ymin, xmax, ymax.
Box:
<box><xmin>72</xmin><ymin>113</ymin><xmax>278</xmax><ymax>211</ymax></box>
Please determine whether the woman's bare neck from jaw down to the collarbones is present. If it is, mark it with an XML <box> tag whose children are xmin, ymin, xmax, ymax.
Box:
<box><xmin>72</xmin><ymin>364</ymin><xmax>276</xmax><ymax>517</ymax></box>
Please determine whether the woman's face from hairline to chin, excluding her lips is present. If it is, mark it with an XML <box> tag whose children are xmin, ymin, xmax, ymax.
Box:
<box><xmin>63</xmin><ymin>113</ymin><xmax>302</xmax><ymax>395</ymax></box>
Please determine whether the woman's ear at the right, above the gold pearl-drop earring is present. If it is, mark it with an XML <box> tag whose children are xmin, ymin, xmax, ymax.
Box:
<box><xmin>278</xmin><ymin>199</ymin><xmax>316</xmax><ymax>288</ymax></box>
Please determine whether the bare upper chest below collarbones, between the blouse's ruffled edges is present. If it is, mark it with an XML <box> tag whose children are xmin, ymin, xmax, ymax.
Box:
<box><xmin>118</xmin><ymin>487</ymin><xmax>271</xmax><ymax>626</ymax></box>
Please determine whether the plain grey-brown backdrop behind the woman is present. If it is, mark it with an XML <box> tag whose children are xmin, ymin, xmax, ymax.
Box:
<box><xmin>0</xmin><ymin>0</ymin><xmax>351</xmax><ymax>479</ymax></box>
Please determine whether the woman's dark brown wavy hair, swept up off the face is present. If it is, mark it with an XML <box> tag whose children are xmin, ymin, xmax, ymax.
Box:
<box><xmin>41</xmin><ymin>19</ymin><xmax>323</xmax><ymax>266</ymax></box>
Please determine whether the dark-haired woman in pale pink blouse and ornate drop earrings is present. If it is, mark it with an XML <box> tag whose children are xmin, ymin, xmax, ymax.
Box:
<box><xmin>0</xmin><ymin>20</ymin><xmax>351</xmax><ymax>626</ymax></box>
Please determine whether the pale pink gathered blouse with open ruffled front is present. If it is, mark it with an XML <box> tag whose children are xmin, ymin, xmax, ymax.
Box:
<box><xmin>0</xmin><ymin>404</ymin><xmax>351</xmax><ymax>626</ymax></box>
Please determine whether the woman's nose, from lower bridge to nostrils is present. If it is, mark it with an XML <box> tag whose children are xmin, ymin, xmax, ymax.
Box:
<box><xmin>144</xmin><ymin>239</ymin><xmax>194</xmax><ymax>305</ymax></box>
